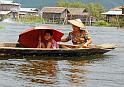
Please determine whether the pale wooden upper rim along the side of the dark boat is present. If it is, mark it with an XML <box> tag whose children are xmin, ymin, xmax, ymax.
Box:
<box><xmin>0</xmin><ymin>43</ymin><xmax>117</xmax><ymax>51</ymax></box>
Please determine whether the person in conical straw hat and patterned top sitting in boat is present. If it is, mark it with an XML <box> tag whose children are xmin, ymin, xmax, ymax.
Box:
<box><xmin>61</xmin><ymin>19</ymin><xmax>92</xmax><ymax>48</ymax></box>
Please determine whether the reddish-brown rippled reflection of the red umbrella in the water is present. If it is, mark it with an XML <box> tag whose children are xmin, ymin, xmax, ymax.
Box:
<box><xmin>19</xmin><ymin>60</ymin><xmax>57</xmax><ymax>84</ymax></box>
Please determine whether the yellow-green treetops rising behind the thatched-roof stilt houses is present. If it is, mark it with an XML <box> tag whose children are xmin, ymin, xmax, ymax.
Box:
<box><xmin>56</xmin><ymin>0</ymin><xmax>105</xmax><ymax>20</ymax></box>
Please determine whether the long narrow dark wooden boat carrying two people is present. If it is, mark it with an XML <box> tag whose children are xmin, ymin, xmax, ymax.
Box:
<box><xmin>0</xmin><ymin>43</ymin><xmax>116</xmax><ymax>57</ymax></box>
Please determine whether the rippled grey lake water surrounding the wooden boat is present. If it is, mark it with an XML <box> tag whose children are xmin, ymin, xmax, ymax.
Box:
<box><xmin>0</xmin><ymin>23</ymin><xmax>124</xmax><ymax>87</ymax></box>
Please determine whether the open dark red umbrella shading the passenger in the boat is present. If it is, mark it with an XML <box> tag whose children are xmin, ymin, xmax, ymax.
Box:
<box><xmin>18</xmin><ymin>26</ymin><xmax>64</xmax><ymax>48</ymax></box>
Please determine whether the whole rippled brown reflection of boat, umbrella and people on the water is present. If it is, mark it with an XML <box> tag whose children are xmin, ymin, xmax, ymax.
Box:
<box><xmin>0</xmin><ymin>56</ymin><xmax>108</xmax><ymax>86</ymax></box>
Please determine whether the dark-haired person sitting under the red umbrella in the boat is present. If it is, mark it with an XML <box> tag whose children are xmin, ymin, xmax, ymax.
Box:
<box><xmin>37</xmin><ymin>30</ymin><xmax>59</xmax><ymax>49</ymax></box>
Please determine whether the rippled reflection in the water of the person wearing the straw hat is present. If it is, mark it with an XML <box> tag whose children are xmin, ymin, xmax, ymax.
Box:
<box><xmin>65</xmin><ymin>60</ymin><xmax>88</xmax><ymax>84</ymax></box>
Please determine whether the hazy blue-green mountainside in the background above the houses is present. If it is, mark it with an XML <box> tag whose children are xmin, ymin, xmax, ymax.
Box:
<box><xmin>14</xmin><ymin>0</ymin><xmax>124</xmax><ymax>9</ymax></box>
